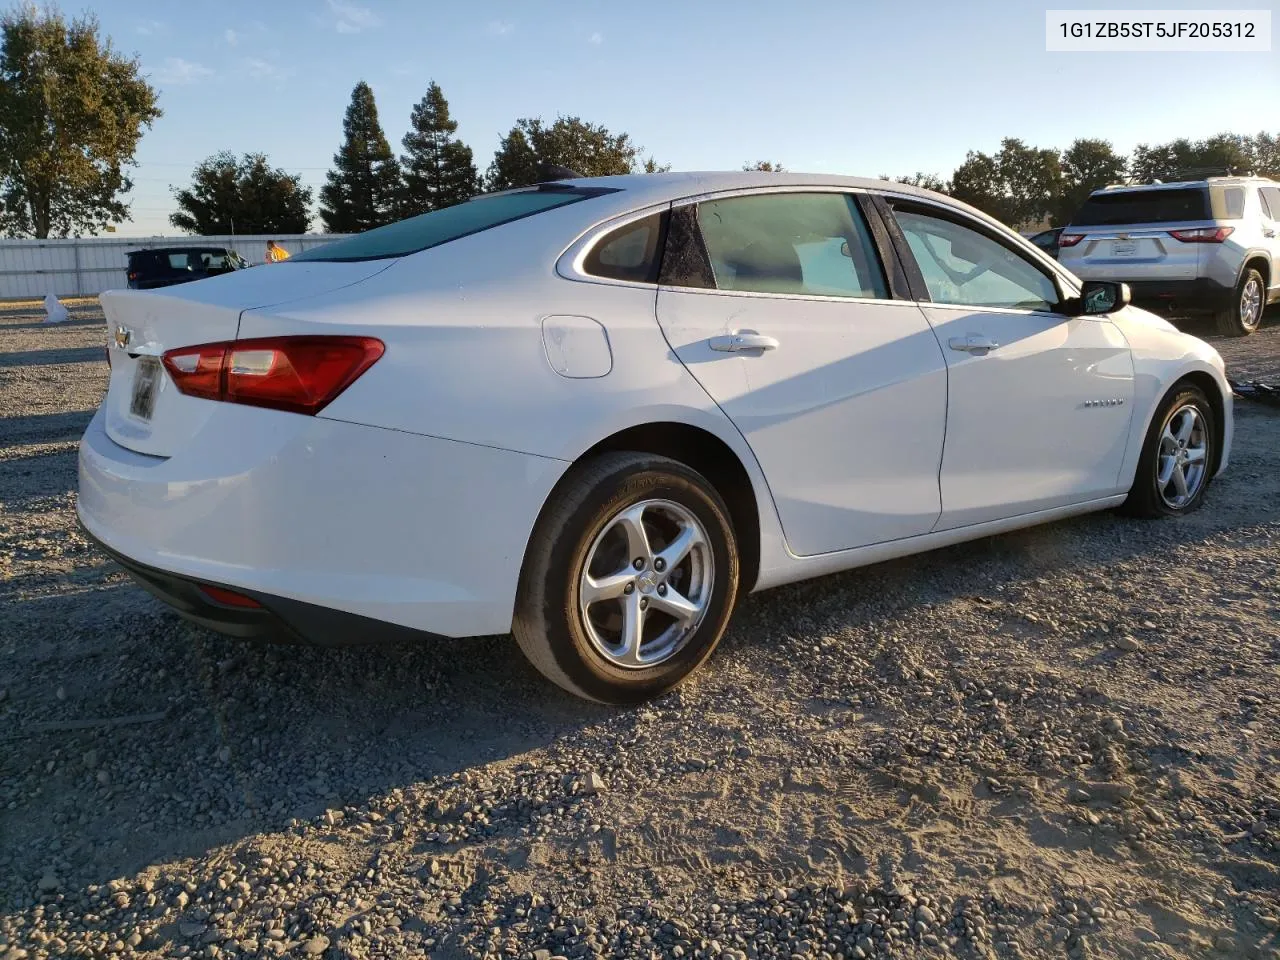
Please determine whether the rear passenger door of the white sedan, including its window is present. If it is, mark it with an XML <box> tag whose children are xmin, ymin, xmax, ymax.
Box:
<box><xmin>658</xmin><ymin>191</ymin><xmax>946</xmax><ymax>556</ymax></box>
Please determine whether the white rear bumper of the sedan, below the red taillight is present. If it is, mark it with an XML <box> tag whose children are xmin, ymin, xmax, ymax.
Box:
<box><xmin>77</xmin><ymin>404</ymin><xmax>566</xmax><ymax>643</ymax></box>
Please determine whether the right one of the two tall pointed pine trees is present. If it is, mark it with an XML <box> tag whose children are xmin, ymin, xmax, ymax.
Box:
<box><xmin>401</xmin><ymin>81</ymin><xmax>480</xmax><ymax>216</ymax></box>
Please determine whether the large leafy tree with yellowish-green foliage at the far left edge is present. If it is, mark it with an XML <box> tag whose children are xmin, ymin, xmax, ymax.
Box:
<box><xmin>0</xmin><ymin>6</ymin><xmax>160</xmax><ymax>239</ymax></box>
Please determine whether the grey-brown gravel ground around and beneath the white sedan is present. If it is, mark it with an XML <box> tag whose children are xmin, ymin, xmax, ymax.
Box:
<box><xmin>0</xmin><ymin>305</ymin><xmax>1280</xmax><ymax>960</ymax></box>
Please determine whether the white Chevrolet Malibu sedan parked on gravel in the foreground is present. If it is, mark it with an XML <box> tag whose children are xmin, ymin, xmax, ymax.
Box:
<box><xmin>78</xmin><ymin>173</ymin><xmax>1231</xmax><ymax>703</ymax></box>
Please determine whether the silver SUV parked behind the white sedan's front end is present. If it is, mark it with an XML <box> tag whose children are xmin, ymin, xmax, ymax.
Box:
<box><xmin>1057</xmin><ymin>177</ymin><xmax>1280</xmax><ymax>337</ymax></box>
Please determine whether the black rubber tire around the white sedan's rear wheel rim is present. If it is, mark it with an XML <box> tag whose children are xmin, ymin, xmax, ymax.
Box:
<box><xmin>512</xmin><ymin>452</ymin><xmax>740</xmax><ymax>704</ymax></box>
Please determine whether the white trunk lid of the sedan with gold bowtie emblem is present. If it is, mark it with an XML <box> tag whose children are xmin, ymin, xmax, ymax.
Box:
<box><xmin>100</xmin><ymin>260</ymin><xmax>394</xmax><ymax>457</ymax></box>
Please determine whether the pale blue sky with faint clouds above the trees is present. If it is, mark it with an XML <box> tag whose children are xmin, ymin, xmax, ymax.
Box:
<box><xmin>99</xmin><ymin>0</ymin><xmax>1280</xmax><ymax>236</ymax></box>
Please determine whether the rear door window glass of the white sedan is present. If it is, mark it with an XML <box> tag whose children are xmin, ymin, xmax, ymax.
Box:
<box><xmin>698</xmin><ymin>193</ymin><xmax>888</xmax><ymax>300</ymax></box>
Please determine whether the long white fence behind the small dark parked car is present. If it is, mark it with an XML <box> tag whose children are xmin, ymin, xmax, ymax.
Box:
<box><xmin>0</xmin><ymin>233</ymin><xmax>348</xmax><ymax>300</ymax></box>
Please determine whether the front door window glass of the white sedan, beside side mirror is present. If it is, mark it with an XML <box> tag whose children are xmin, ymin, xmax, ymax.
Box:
<box><xmin>895</xmin><ymin>210</ymin><xmax>1059</xmax><ymax>311</ymax></box>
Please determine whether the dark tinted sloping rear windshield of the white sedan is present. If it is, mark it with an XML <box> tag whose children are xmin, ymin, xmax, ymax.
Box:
<box><xmin>293</xmin><ymin>183</ymin><xmax>616</xmax><ymax>261</ymax></box>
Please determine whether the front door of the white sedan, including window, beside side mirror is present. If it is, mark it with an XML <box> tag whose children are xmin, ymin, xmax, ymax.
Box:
<box><xmin>888</xmin><ymin>197</ymin><xmax>1134</xmax><ymax>530</ymax></box>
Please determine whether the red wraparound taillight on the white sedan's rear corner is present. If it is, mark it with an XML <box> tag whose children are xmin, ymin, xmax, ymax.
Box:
<box><xmin>164</xmin><ymin>337</ymin><xmax>385</xmax><ymax>415</ymax></box>
